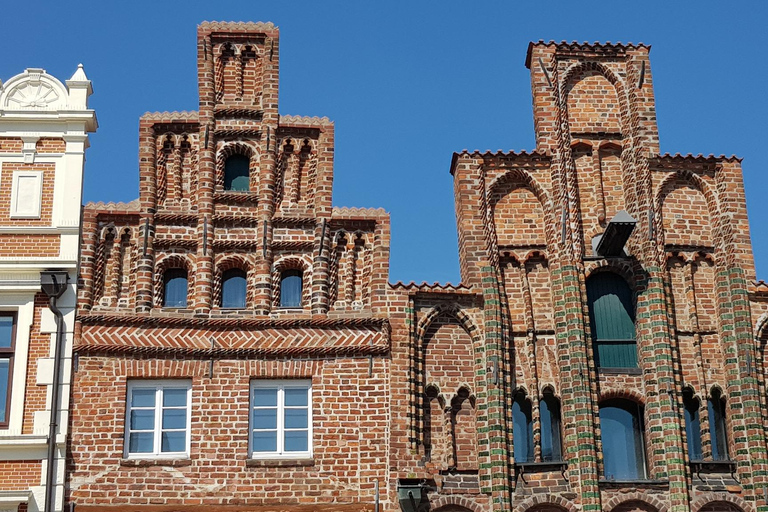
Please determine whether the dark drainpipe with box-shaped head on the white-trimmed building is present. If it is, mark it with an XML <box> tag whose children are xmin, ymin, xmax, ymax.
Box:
<box><xmin>40</xmin><ymin>270</ymin><xmax>69</xmax><ymax>512</ymax></box>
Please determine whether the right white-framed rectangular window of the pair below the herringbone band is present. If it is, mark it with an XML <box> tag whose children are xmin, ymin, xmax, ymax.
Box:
<box><xmin>249</xmin><ymin>380</ymin><xmax>312</xmax><ymax>459</ymax></box>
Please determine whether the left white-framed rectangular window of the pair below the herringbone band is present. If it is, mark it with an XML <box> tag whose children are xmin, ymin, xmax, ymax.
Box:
<box><xmin>125</xmin><ymin>380</ymin><xmax>192</xmax><ymax>458</ymax></box>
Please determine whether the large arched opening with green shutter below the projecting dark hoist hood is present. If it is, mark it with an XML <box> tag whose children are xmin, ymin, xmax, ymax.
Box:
<box><xmin>587</xmin><ymin>272</ymin><xmax>637</xmax><ymax>368</ymax></box>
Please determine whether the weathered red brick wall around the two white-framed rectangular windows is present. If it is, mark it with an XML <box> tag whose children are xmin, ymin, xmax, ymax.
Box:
<box><xmin>70</xmin><ymin>355</ymin><xmax>389</xmax><ymax>510</ymax></box>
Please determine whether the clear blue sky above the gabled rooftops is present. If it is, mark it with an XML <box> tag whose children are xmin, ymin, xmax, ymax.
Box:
<box><xmin>0</xmin><ymin>0</ymin><xmax>768</xmax><ymax>282</ymax></box>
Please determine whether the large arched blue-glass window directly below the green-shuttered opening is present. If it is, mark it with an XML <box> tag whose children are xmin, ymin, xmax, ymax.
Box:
<box><xmin>600</xmin><ymin>399</ymin><xmax>646</xmax><ymax>480</ymax></box>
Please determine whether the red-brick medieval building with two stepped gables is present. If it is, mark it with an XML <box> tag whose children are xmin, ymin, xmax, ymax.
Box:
<box><xmin>69</xmin><ymin>23</ymin><xmax>768</xmax><ymax>512</ymax></box>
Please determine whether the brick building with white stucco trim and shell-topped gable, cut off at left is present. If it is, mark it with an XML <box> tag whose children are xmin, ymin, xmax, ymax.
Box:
<box><xmin>0</xmin><ymin>66</ymin><xmax>97</xmax><ymax>512</ymax></box>
